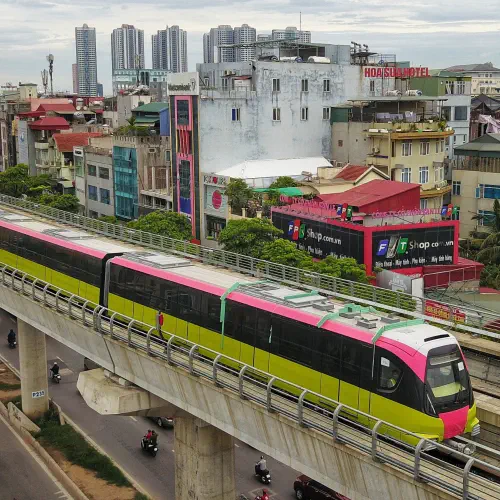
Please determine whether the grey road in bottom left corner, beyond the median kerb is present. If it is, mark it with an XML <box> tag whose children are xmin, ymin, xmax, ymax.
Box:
<box><xmin>0</xmin><ymin>410</ymin><xmax>70</xmax><ymax>500</ymax></box>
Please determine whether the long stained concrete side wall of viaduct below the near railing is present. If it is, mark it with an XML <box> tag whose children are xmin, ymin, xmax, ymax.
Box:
<box><xmin>0</xmin><ymin>286</ymin><xmax>464</xmax><ymax>500</ymax></box>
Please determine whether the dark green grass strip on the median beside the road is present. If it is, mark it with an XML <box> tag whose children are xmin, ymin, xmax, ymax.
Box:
<box><xmin>35</xmin><ymin>410</ymin><xmax>132</xmax><ymax>487</ymax></box>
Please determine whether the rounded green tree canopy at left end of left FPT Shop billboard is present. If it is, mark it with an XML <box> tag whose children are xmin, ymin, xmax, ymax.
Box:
<box><xmin>219</xmin><ymin>219</ymin><xmax>282</xmax><ymax>258</ymax></box>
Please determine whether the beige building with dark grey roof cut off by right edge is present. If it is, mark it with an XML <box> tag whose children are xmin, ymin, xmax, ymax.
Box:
<box><xmin>451</xmin><ymin>133</ymin><xmax>500</xmax><ymax>238</ymax></box>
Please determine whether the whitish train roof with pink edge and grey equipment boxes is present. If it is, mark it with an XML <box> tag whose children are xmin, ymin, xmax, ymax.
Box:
<box><xmin>0</xmin><ymin>209</ymin><xmax>456</xmax><ymax>354</ymax></box>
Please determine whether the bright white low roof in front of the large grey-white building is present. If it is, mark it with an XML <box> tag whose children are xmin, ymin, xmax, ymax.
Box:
<box><xmin>214</xmin><ymin>156</ymin><xmax>332</xmax><ymax>182</ymax></box>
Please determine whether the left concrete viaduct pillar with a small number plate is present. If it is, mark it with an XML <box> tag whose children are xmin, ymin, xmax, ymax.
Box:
<box><xmin>17</xmin><ymin>318</ymin><xmax>49</xmax><ymax>420</ymax></box>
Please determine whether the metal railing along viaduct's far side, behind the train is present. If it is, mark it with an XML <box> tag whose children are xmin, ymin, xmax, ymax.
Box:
<box><xmin>0</xmin><ymin>191</ymin><xmax>500</xmax><ymax>340</ymax></box>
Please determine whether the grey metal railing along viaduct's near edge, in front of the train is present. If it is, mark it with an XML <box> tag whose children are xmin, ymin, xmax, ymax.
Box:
<box><xmin>0</xmin><ymin>263</ymin><xmax>500</xmax><ymax>500</ymax></box>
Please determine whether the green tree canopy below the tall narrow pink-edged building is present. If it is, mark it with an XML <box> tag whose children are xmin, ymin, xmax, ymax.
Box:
<box><xmin>127</xmin><ymin>212</ymin><xmax>192</xmax><ymax>240</ymax></box>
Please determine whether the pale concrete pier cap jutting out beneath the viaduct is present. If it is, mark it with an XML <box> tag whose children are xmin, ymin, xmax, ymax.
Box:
<box><xmin>76</xmin><ymin>368</ymin><xmax>189</xmax><ymax>418</ymax></box>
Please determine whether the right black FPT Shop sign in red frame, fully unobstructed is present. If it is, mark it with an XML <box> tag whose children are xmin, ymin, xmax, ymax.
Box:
<box><xmin>372</xmin><ymin>226</ymin><xmax>455</xmax><ymax>269</ymax></box>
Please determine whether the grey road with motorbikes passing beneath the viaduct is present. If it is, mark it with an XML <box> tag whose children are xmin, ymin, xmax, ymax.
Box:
<box><xmin>0</xmin><ymin>310</ymin><xmax>299</xmax><ymax>500</ymax></box>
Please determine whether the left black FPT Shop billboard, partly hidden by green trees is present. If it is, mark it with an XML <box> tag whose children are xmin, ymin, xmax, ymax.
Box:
<box><xmin>272</xmin><ymin>212</ymin><xmax>364</xmax><ymax>263</ymax></box>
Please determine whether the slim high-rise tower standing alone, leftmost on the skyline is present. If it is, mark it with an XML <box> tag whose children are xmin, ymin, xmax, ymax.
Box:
<box><xmin>75</xmin><ymin>24</ymin><xmax>97</xmax><ymax>97</ymax></box>
